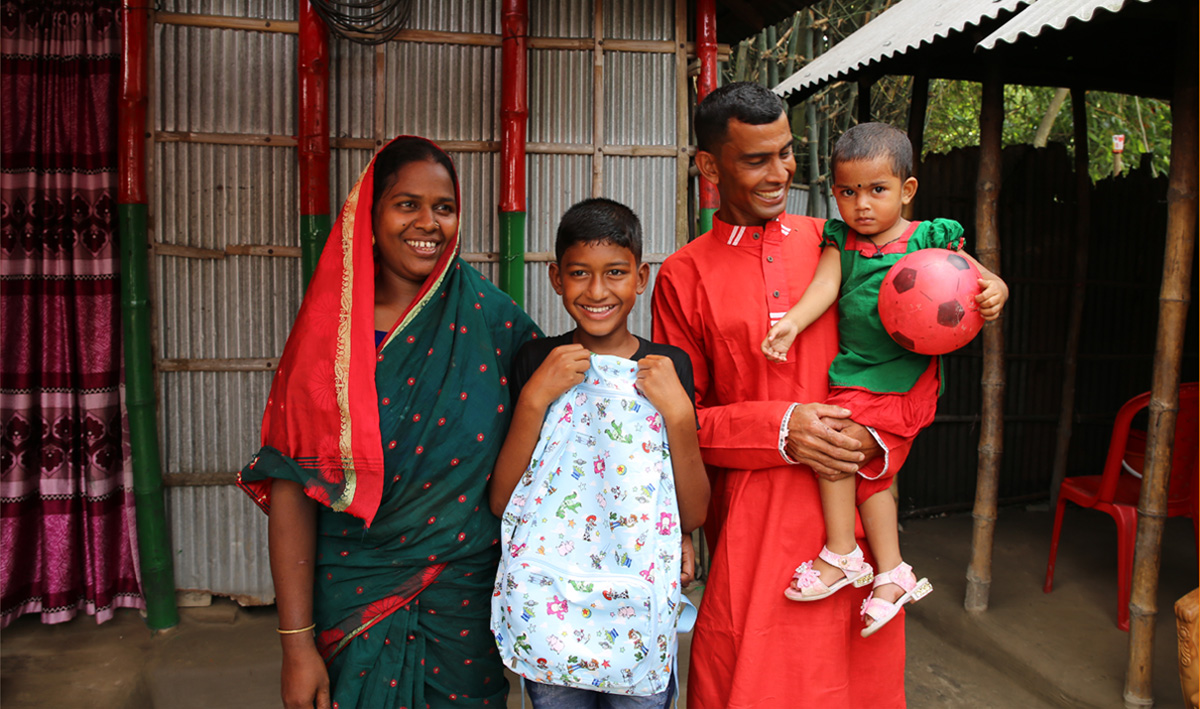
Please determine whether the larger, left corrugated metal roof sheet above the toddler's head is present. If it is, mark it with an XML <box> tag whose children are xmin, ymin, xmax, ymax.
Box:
<box><xmin>774</xmin><ymin>0</ymin><xmax>1033</xmax><ymax>97</ymax></box>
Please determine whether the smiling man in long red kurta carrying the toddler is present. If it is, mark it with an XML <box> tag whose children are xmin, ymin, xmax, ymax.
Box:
<box><xmin>653</xmin><ymin>83</ymin><xmax>905</xmax><ymax>709</ymax></box>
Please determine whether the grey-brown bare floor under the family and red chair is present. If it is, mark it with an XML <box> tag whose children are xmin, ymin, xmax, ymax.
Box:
<box><xmin>0</xmin><ymin>509</ymin><xmax>1198</xmax><ymax>709</ymax></box>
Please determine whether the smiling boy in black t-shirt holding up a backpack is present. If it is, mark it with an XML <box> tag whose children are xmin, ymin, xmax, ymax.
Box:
<box><xmin>488</xmin><ymin>198</ymin><xmax>709</xmax><ymax>709</ymax></box>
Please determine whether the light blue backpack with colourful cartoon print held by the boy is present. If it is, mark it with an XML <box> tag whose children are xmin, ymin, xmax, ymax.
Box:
<box><xmin>492</xmin><ymin>355</ymin><xmax>680</xmax><ymax>696</ymax></box>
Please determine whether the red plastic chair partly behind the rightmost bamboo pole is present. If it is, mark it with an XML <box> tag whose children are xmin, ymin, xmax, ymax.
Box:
<box><xmin>1043</xmin><ymin>381</ymin><xmax>1200</xmax><ymax>630</ymax></box>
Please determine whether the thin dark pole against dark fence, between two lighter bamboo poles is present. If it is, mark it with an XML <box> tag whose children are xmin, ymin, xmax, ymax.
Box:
<box><xmin>1050</xmin><ymin>88</ymin><xmax>1092</xmax><ymax>509</ymax></box>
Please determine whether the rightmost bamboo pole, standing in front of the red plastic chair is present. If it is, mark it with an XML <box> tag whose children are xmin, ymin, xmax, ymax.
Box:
<box><xmin>1124</xmin><ymin>5</ymin><xmax>1198</xmax><ymax>707</ymax></box>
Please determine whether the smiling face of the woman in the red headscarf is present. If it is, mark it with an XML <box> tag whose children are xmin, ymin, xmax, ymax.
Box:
<box><xmin>371</xmin><ymin>160</ymin><xmax>458</xmax><ymax>286</ymax></box>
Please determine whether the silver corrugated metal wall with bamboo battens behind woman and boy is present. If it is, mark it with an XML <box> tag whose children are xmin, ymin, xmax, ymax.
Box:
<box><xmin>150</xmin><ymin>0</ymin><xmax>686</xmax><ymax>602</ymax></box>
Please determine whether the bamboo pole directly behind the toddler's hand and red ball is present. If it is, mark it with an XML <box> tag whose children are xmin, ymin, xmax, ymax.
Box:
<box><xmin>962</xmin><ymin>61</ymin><xmax>1004</xmax><ymax>612</ymax></box>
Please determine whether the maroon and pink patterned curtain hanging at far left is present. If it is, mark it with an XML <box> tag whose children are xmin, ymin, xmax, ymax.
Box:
<box><xmin>0</xmin><ymin>0</ymin><xmax>143</xmax><ymax>627</ymax></box>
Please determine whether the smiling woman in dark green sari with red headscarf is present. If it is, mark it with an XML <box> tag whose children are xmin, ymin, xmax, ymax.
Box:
<box><xmin>239</xmin><ymin>137</ymin><xmax>538</xmax><ymax>709</ymax></box>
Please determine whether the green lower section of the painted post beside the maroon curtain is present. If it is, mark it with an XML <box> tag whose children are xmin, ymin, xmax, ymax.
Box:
<box><xmin>116</xmin><ymin>204</ymin><xmax>179</xmax><ymax>630</ymax></box>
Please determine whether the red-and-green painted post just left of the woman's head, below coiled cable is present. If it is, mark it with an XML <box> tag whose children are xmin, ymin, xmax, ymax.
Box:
<box><xmin>296</xmin><ymin>0</ymin><xmax>330</xmax><ymax>284</ymax></box>
